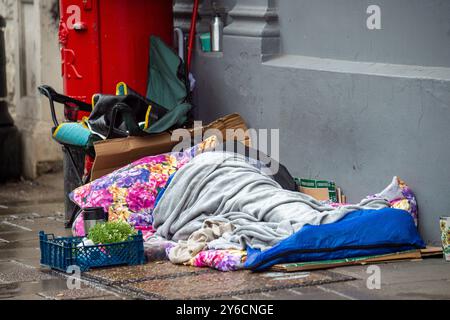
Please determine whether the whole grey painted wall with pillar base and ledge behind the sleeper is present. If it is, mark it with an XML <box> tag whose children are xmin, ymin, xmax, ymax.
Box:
<box><xmin>175</xmin><ymin>0</ymin><xmax>450</xmax><ymax>245</ymax></box>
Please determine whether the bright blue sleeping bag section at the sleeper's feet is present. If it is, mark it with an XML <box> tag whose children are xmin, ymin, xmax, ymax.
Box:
<box><xmin>244</xmin><ymin>208</ymin><xmax>425</xmax><ymax>271</ymax></box>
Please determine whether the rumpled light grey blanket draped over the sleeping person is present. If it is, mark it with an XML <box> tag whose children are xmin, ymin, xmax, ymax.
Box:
<box><xmin>153</xmin><ymin>151</ymin><xmax>388</xmax><ymax>249</ymax></box>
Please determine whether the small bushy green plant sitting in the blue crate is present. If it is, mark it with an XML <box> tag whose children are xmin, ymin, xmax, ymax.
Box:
<box><xmin>88</xmin><ymin>221</ymin><xmax>137</xmax><ymax>244</ymax></box>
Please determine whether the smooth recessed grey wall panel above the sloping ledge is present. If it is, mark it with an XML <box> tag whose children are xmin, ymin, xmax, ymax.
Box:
<box><xmin>278</xmin><ymin>0</ymin><xmax>450</xmax><ymax>67</ymax></box>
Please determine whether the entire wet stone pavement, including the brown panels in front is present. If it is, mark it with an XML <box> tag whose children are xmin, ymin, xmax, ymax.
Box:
<box><xmin>0</xmin><ymin>173</ymin><xmax>450</xmax><ymax>300</ymax></box>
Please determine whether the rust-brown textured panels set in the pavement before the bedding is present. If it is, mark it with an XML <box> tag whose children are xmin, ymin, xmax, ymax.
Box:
<box><xmin>84</xmin><ymin>261</ymin><xmax>354</xmax><ymax>299</ymax></box>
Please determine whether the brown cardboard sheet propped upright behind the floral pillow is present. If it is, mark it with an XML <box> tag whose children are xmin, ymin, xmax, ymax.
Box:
<box><xmin>91</xmin><ymin>113</ymin><xmax>250</xmax><ymax>180</ymax></box>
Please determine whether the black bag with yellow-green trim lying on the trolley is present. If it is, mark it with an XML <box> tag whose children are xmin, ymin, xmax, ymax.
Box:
<box><xmin>87</xmin><ymin>87</ymin><xmax>168</xmax><ymax>139</ymax></box>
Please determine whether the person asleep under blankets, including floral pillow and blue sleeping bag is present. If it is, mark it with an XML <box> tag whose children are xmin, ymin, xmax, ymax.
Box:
<box><xmin>71</xmin><ymin>136</ymin><xmax>423</xmax><ymax>270</ymax></box>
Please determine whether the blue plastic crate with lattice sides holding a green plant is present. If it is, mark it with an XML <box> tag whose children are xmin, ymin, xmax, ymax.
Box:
<box><xmin>39</xmin><ymin>231</ymin><xmax>145</xmax><ymax>272</ymax></box>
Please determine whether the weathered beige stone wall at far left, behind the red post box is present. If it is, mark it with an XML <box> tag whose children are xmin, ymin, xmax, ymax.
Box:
<box><xmin>0</xmin><ymin>0</ymin><xmax>62</xmax><ymax>178</ymax></box>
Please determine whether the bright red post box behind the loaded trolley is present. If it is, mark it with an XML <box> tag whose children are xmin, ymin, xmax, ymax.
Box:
<box><xmin>59</xmin><ymin>0</ymin><xmax>173</xmax><ymax>119</ymax></box>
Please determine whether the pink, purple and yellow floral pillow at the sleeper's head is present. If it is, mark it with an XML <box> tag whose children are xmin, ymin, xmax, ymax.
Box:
<box><xmin>70</xmin><ymin>152</ymin><xmax>193</xmax><ymax>235</ymax></box>
